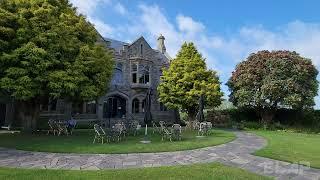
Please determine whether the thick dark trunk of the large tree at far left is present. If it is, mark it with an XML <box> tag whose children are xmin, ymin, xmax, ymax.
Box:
<box><xmin>18</xmin><ymin>99</ymin><xmax>40</xmax><ymax>132</ymax></box>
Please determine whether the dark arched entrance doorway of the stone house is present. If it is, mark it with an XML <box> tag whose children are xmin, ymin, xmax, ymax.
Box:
<box><xmin>103</xmin><ymin>96</ymin><xmax>126</xmax><ymax>118</ymax></box>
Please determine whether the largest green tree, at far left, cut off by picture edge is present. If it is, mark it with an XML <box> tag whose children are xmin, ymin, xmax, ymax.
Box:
<box><xmin>0</xmin><ymin>0</ymin><xmax>113</xmax><ymax>129</ymax></box>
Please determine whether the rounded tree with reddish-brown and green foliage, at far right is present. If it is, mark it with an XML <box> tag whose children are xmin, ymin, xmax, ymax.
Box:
<box><xmin>227</xmin><ymin>51</ymin><xmax>318</xmax><ymax>123</ymax></box>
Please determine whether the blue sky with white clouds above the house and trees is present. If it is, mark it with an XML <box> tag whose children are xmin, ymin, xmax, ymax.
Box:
<box><xmin>71</xmin><ymin>0</ymin><xmax>320</xmax><ymax>108</ymax></box>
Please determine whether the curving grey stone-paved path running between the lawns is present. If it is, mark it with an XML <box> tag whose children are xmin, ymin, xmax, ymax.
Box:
<box><xmin>0</xmin><ymin>132</ymin><xmax>320</xmax><ymax>180</ymax></box>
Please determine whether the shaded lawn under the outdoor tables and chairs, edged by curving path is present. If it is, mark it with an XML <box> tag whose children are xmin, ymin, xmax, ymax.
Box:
<box><xmin>0</xmin><ymin>130</ymin><xmax>235</xmax><ymax>153</ymax></box>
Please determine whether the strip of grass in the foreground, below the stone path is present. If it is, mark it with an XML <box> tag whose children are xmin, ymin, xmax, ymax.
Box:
<box><xmin>0</xmin><ymin>163</ymin><xmax>271</xmax><ymax>180</ymax></box>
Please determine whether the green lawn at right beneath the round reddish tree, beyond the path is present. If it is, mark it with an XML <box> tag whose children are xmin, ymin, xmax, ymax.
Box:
<box><xmin>252</xmin><ymin>131</ymin><xmax>320</xmax><ymax>168</ymax></box>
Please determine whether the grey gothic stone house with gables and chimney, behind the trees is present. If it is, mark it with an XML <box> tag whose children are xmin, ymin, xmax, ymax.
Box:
<box><xmin>0</xmin><ymin>35</ymin><xmax>178</xmax><ymax>126</ymax></box>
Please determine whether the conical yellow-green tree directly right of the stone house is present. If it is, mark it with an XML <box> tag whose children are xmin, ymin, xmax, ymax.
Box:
<box><xmin>158</xmin><ymin>43</ymin><xmax>223</xmax><ymax>120</ymax></box>
